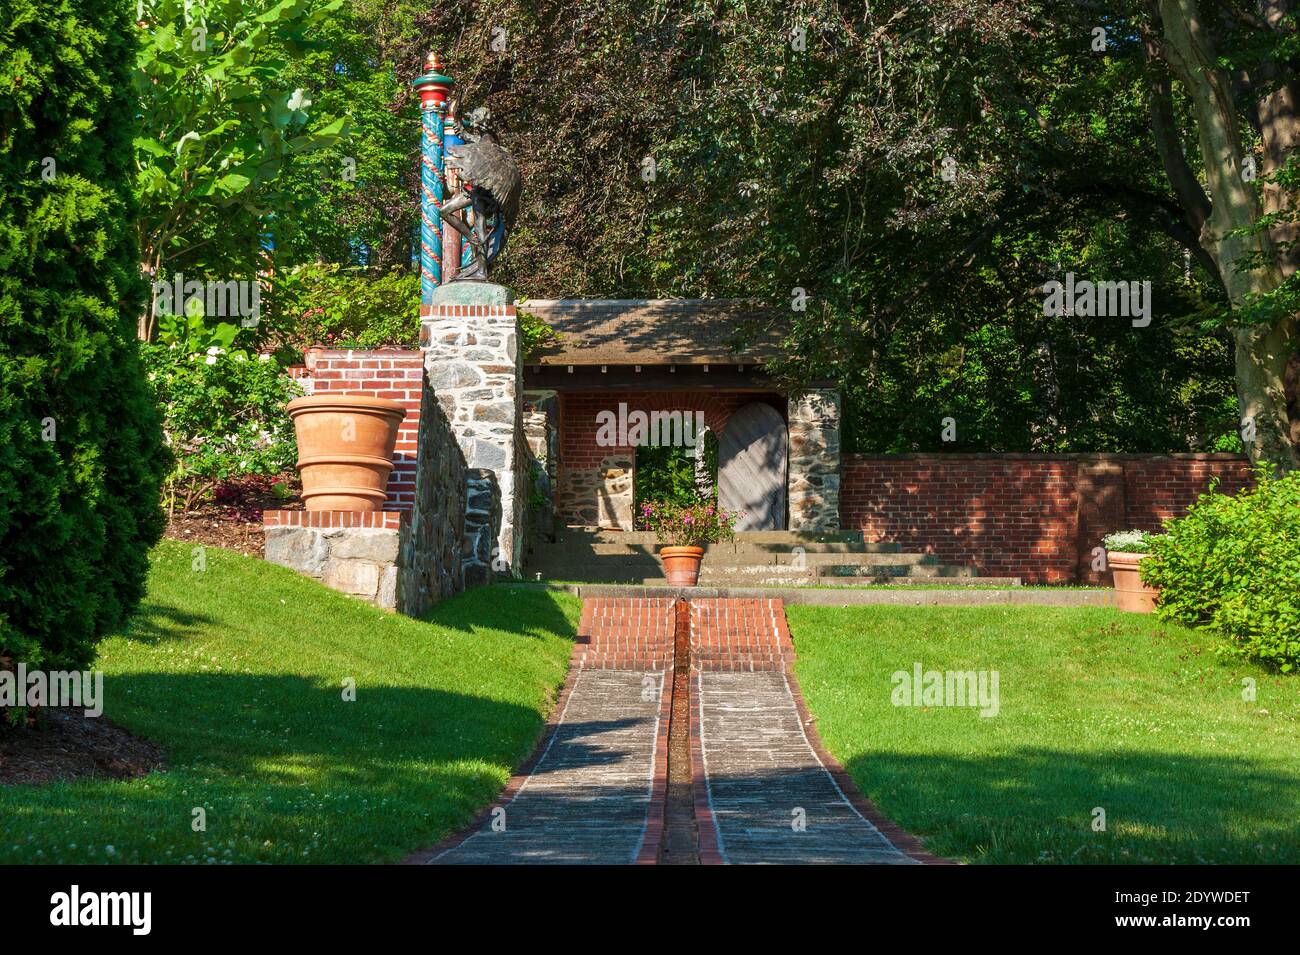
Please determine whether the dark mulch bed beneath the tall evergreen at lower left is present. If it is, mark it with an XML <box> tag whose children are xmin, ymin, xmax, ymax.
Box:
<box><xmin>0</xmin><ymin>707</ymin><xmax>163</xmax><ymax>786</ymax></box>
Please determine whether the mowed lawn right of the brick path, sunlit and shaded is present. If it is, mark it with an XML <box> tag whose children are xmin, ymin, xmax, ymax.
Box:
<box><xmin>787</xmin><ymin>607</ymin><xmax>1300</xmax><ymax>863</ymax></box>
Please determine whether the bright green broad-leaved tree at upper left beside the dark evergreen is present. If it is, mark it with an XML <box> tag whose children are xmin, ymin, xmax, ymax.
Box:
<box><xmin>134</xmin><ymin>0</ymin><xmax>348</xmax><ymax>287</ymax></box>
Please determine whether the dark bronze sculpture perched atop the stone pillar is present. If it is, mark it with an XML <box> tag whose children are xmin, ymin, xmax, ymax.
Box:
<box><xmin>442</xmin><ymin>116</ymin><xmax>523</xmax><ymax>281</ymax></box>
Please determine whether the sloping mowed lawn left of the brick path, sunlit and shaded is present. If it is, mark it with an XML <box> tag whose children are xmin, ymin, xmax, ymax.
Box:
<box><xmin>0</xmin><ymin>542</ymin><xmax>580</xmax><ymax>863</ymax></box>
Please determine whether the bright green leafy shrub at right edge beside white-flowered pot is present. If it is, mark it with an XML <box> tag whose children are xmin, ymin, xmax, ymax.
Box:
<box><xmin>1141</xmin><ymin>472</ymin><xmax>1300</xmax><ymax>673</ymax></box>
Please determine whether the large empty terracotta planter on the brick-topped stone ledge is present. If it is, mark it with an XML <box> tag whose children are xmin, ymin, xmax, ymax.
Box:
<box><xmin>289</xmin><ymin>394</ymin><xmax>406</xmax><ymax>511</ymax></box>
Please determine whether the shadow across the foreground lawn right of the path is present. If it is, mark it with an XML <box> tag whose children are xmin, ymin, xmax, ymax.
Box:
<box><xmin>846</xmin><ymin>748</ymin><xmax>1300</xmax><ymax>863</ymax></box>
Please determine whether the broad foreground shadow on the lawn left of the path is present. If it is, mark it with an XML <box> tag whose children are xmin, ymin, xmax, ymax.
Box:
<box><xmin>0</xmin><ymin>673</ymin><xmax>585</xmax><ymax>863</ymax></box>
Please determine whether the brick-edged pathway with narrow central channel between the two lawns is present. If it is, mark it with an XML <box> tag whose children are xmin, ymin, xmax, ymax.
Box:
<box><xmin>412</xmin><ymin>598</ymin><xmax>943</xmax><ymax>864</ymax></box>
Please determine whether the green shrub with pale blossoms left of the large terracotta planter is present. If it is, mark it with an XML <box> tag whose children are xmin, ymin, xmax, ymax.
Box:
<box><xmin>143</xmin><ymin>316</ymin><xmax>302</xmax><ymax>511</ymax></box>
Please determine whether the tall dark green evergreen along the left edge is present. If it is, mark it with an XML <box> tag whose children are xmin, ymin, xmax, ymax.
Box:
<box><xmin>0</xmin><ymin>0</ymin><xmax>166</xmax><ymax>669</ymax></box>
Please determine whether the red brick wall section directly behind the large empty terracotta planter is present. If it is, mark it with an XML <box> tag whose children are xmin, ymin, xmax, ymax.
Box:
<box><xmin>299</xmin><ymin>350</ymin><xmax>424</xmax><ymax>511</ymax></box>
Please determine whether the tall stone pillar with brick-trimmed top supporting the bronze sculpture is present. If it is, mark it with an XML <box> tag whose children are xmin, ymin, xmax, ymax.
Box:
<box><xmin>420</xmin><ymin>282</ymin><xmax>528</xmax><ymax>586</ymax></box>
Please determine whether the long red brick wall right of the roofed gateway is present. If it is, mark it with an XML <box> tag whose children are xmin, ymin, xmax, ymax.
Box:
<box><xmin>840</xmin><ymin>455</ymin><xmax>1251</xmax><ymax>583</ymax></box>
